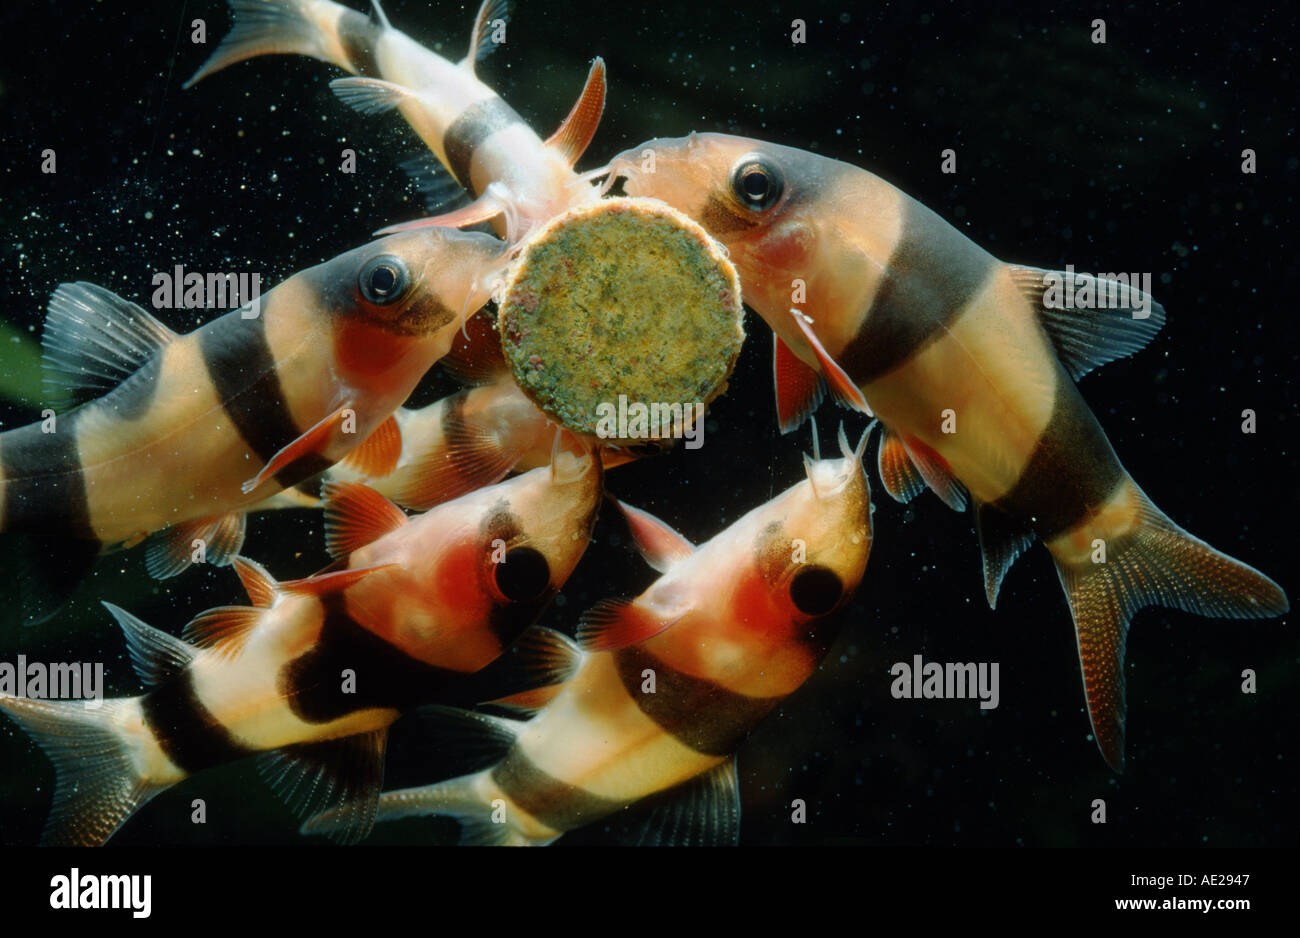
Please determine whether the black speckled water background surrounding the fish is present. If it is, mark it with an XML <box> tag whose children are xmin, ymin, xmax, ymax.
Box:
<box><xmin>0</xmin><ymin>0</ymin><xmax>1300</xmax><ymax>847</ymax></box>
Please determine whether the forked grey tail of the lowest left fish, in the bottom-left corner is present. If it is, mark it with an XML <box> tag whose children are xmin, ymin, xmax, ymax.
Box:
<box><xmin>0</xmin><ymin>698</ymin><xmax>166</xmax><ymax>847</ymax></box>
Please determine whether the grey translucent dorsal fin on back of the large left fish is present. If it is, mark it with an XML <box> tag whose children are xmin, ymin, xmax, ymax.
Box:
<box><xmin>40</xmin><ymin>282</ymin><xmax>177</xmax><ymax>411</ymax></box>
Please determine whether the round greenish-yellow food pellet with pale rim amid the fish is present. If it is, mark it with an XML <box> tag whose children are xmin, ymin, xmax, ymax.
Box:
<box><xmin>498</xmin><ymin>199</ymin><xmax>745</xmax><ymax>444</ymax></box>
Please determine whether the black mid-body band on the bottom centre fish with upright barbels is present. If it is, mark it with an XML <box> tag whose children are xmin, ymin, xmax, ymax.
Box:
<box><xmin>614</xmin><ymin>644</ymin><xmax>784</xmax><ymax>756</ymax></box>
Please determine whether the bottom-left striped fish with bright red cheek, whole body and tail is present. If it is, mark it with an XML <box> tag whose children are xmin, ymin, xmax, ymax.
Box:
<box><xmin>0</xmin><ymin>444</ymin><xmax>602</xmax><ymax>846</ymax></box>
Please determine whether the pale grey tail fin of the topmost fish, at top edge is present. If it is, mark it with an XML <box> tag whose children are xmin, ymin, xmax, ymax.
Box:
<box><xmin>182</xmin><ymin>0</ymin><xmax>365</xmax><ymax>88</ymax></box>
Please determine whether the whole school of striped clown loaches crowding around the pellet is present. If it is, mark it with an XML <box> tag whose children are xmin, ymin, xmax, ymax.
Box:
<box><xmin>0</xmin><ymin>0</ymin><xmax>1288</xmax><ymax>846</ymax></box>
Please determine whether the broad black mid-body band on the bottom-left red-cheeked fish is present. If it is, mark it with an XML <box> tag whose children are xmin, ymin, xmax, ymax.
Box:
<box><xmin>278</xmin><ymin>592</ymin><xmax>465</xmax><ymax>724</ymax></box>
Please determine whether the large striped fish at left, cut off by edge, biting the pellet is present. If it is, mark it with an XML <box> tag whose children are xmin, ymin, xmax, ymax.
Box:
<box><xmin>0</xmin><ymin>231</ymin><xmax>501</xmax><ymax>618</ymax></box>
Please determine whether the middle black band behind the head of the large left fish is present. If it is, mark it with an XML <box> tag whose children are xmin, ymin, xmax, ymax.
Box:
<box><xmin>199</xmin><ymin>312</ymin><xmax>332</xmax><ymax>488</ymax></box>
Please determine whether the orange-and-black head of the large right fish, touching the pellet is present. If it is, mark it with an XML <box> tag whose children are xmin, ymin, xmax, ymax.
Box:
<box><xmin>610</xmin><ymin>134</ymin><xmax>874</xmax><ymax>361</ymax></box>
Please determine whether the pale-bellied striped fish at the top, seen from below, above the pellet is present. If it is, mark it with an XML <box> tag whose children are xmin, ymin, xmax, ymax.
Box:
<box><xmin>186</xmin><ymin>0</ymin><xmax>603</xmax><ymax>232</ymax></box>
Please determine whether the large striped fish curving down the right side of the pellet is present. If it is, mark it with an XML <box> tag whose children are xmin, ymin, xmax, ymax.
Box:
<box><xmin>611</xmin><ymin>134</ymin><xmax>1288</xmax><ymax>770</ymax></box>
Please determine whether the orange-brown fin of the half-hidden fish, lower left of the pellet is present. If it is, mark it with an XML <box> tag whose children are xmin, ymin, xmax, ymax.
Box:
<box><xmin>393</xmin><ymin>391</ymin><xmax>524</xmax><ymax>511</ymax></box>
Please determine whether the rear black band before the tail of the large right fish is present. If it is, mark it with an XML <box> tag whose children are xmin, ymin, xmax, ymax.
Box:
<box><xmin>992</xmin><ymin>368</ymin><xmax>1125</xmax><ymax>540</ymax></box>
